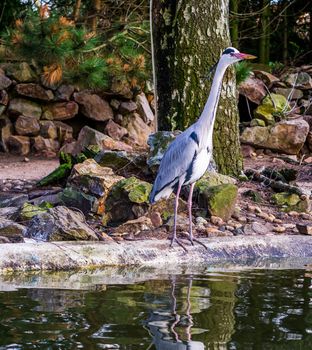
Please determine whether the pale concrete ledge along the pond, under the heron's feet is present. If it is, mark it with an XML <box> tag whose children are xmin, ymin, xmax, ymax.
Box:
<box><xmin>0</xmin><ymin>235</ymin><xmax>312</xmax><ymax>273</ymax></box>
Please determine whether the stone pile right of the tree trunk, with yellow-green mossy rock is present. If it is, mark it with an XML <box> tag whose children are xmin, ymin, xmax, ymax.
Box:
<box><xmin>239</xmin><ymin>65</ymin><xmax>312</xmax><ymax>155</ymax></box>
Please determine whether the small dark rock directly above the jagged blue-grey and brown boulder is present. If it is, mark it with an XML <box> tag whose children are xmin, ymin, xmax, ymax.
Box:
<box><xmin>59</xmin><ymin>186</ymin><xmax>99</xmax><ymax>215</ymax></box>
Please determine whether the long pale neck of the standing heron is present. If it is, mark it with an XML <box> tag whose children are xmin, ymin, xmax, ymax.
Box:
<box><xmin>198</xmin><ymin>61</ymin><xmax>227</xmax><ymax>132</ymax></box>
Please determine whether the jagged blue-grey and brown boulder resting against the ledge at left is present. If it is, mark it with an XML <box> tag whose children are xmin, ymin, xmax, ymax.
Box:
<box><xmin>26</xmin><ymin>206</ymin><xmax>98</xmax><ymax>241</ymax></box>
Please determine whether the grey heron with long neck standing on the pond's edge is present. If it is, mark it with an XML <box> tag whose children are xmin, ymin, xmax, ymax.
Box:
<box><xmin>150</xmin><ymin>47</ymin><xmax>256</xmax><ymax>250</ymax></box>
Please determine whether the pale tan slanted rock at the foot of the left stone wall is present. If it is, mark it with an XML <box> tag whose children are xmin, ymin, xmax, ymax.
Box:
<box><xmin>74</xmin><ymin>126</ymin><xmax>132</xmax><ymax>154</ymax></box>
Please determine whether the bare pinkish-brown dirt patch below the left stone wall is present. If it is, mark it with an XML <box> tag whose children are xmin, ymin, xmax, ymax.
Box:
<box><xmin>0</xmin><ymin>153</ymin><xmax>59</xmax><ymax>181</ymax></box>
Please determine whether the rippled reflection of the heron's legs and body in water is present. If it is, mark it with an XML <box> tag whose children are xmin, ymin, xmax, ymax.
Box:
<box><xmin>146</xmin><ymin>276</ymin><xmax>205</xmax><ymax>350</ymax></box>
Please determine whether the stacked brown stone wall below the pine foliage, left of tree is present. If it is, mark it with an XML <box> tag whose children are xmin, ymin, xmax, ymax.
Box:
<box><xmin>0</xmin><ymin>63</ymin><xmax>154</xmax><ymax>157</ymax></box>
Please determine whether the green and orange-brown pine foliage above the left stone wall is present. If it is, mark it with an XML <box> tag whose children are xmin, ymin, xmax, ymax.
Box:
<box><xmin>0</xmin><ymin>6</ymin><xmax>149</xmax><ymax>89</ymax></box>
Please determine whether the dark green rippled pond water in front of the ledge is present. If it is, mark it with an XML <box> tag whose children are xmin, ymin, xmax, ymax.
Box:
<box><xmin>0</xmin><ymin>267</ymin><xmax>312</xmax><ymax>350</ymax></box>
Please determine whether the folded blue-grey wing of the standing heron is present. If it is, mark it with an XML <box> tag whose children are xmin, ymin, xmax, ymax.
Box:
<box><xmin>150</xmin><ymin>132</ymin><xmax>199</xmax><ymax>202</ymax></box>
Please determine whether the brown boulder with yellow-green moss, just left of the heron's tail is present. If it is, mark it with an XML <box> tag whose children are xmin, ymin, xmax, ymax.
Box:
<box><xmin>105</xmin><ymin>177</ymin><xmax>152</xmax><ymax>225</ymax></box>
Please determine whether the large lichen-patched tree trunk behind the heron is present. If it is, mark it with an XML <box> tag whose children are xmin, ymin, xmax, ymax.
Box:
<box><xmin>152</xmin><ymin>0</ymin><xmax>242</xmax><ymax>174</ymax></box>
